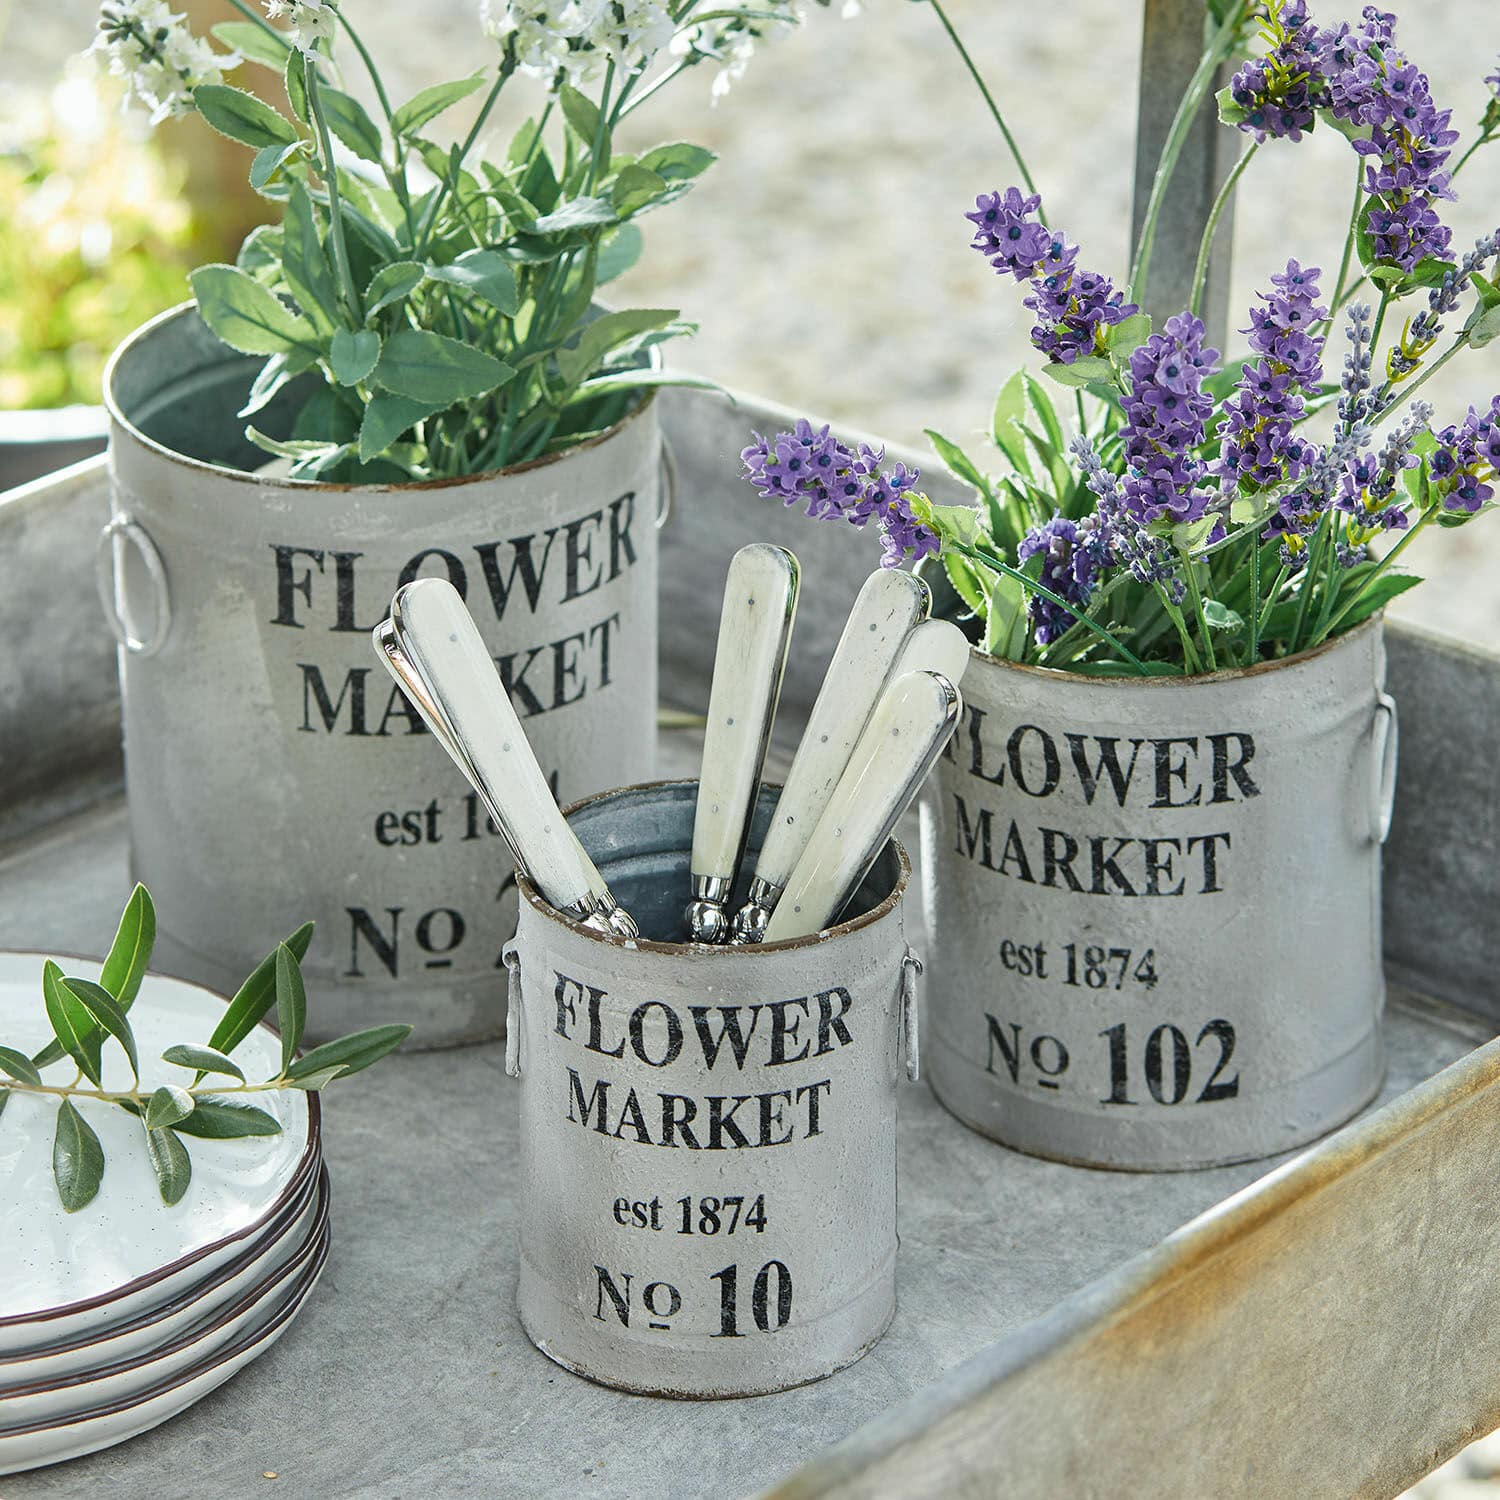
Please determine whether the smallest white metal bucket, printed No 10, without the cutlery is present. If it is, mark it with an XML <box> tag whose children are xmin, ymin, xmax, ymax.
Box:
<box><xmin>507</xmin><ymin>782</ymin><xmax>921</xmax><ymax>1397</ymax></box>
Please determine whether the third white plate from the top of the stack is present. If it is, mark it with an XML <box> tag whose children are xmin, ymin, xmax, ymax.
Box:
<box><xmin>0</xmin><ymin>1176</ymin><xmax>329</xmax><ymax>1437</ymax></box>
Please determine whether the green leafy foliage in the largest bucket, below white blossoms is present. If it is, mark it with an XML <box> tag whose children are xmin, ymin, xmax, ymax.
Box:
<box><xmin>158</xmin><ymin>12</ymin><xmax>732</xmax><ymax>482</ymax></box>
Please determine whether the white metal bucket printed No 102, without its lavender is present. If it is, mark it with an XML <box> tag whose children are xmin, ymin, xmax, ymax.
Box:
<box><xmin>923</xmin><ymin>620</ymin><xmax>1397</xmax><ymax>1170</ymax></box>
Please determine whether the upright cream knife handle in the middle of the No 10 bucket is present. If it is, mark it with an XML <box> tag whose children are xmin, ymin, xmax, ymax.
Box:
<box><xmin>693</xmin><ymin>542</ymin><xmax>798</xmax><ymax>876</ymax></box>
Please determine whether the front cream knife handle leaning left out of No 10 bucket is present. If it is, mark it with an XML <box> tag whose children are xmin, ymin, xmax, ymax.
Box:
<box><xmin>392</xmin><ymin>578</ymin><xmax>609</xmax><ymax>909</ymax></box>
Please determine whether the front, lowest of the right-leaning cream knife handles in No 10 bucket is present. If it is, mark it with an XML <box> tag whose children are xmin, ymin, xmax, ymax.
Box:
<box><xmin>765</xmin><ymin>672</ymin><xmax>962</xmax><ymax>942</ymax></box>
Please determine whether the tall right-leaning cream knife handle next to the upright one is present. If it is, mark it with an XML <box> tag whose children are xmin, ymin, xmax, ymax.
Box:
<box><xmin>755</xmin><ymin>569</ymin><xmax>932</xmax><ymax>890</ymax></box>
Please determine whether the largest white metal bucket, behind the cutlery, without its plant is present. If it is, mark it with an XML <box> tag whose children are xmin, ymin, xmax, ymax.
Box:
<box><xmin>101</xmin><ymin>308</ymin><xmax>663</xmax><ymax>1046</ymax></box>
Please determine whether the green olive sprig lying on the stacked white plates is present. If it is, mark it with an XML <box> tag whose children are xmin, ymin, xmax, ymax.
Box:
<box><xmin>0</xmin><ymin>885</ymin><xmax>411</xmax><ymax>1214</ymax></box>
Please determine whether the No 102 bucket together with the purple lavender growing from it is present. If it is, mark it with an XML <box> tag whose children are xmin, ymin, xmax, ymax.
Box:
<box><xmin>732</xmin><ymin>0</ymin><xmax>1500</xmax><ymax>1170</ymax></box>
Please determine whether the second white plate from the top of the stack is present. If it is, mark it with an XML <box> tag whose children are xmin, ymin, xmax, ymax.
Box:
<box><xmin>0</xmin><ymin>1170</ymin><xmax>329</xmax><ymax>1386</ymax></box>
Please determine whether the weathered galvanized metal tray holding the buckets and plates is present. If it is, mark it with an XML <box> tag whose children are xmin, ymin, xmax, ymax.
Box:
<box><xmin>0</xmin><ymin>395</ymin><xmax>1500</xmax><ymax>1500</ymax></box>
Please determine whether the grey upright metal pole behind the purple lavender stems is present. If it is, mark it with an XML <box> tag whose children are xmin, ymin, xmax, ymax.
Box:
<box><xmin>1131</xmin><ymin>0</ymin><xmax>1242</xmax><ymax>348</ymax></box>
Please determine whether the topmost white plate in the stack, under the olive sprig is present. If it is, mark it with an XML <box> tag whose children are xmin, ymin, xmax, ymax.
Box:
<box><xmin>0</xmin><ymin>953</ymin><xmax>318</xmax><ymax>1356</ymax></box>
